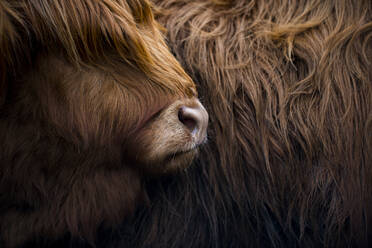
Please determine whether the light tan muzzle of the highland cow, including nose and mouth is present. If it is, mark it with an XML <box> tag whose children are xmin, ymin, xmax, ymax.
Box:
<box><xmin>137</xmin><ymin>98</ymin><xmax>208</xmax><ymax>173</ymax></box>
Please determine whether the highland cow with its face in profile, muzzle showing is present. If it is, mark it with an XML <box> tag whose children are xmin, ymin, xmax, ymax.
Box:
<box><xmin>0</xmin><ymin>0</ymin><xmax>208</xmax><ymax>247</ymax></box>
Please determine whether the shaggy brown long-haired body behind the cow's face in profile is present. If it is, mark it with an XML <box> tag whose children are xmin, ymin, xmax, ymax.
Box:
<box><xmin>112</xmin><ymin>0</ymin><xmax>372</xmax><ymax>248</ymax></box>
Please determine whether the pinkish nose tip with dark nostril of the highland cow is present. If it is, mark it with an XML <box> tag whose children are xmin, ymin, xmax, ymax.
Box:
<box><xmin>178</xmin><ymin>101</ymin><xmax>208</xmax><ymax>144</ymax></box>
